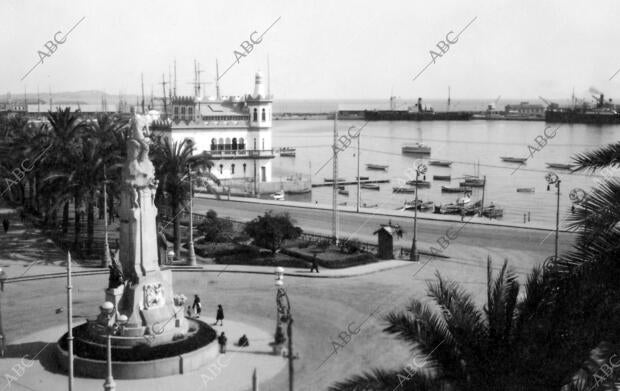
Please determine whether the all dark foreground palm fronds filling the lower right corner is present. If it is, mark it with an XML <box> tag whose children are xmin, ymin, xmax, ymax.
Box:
<box><xmin>330</xmin><ymin>143</ymin><xmax>620</xmax><ymax>391</ymax></box>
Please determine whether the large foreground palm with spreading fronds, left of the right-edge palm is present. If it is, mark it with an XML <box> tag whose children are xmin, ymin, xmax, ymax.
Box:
<box><xmin>330</xmin><ymin>259</ymin><xmax>617</xmax><ymax>391</ymax></box>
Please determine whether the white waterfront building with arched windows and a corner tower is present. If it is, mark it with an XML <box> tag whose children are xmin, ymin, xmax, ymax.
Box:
<box><xmin>151</xmin><ymin>72</ymin><xmax>276</xmax><ymax>193</ymax></box>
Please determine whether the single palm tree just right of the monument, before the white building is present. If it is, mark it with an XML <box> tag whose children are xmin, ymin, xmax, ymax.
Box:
<box><xmin>151</xmin><ymin>137</ymin><xmax>220</xmax><ymax>258</ymax></box>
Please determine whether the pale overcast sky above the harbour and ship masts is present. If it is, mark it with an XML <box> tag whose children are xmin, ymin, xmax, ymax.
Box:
<box><xmin>0</xmin><ymin>0</ymin><xmax>620</xmax><ymax>101</ymax></box>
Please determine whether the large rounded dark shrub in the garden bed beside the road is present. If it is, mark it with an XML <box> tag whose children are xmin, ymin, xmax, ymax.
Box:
<box><xmin>245</xmin><ymin>211</ymin><xmax>302</xmax><ymax>254</ymax></box>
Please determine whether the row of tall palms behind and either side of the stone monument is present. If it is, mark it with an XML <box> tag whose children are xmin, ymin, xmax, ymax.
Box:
<box><xmin>0</xmin><ymin>108</ymin><xmax>217</xmax><ymax>258</ymax></box>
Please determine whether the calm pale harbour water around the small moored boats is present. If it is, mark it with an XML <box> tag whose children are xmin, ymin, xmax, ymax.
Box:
<box><xmin>273</xmin><ymin>120</ymin><xmax>620</xmax><ymax>228</ymax></box>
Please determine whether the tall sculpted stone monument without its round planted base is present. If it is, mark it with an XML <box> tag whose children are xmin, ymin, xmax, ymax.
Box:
<box><xmin>101</xmin><ymin>116</ymin><xmax>184</xmax><ymax>336</ymax></box>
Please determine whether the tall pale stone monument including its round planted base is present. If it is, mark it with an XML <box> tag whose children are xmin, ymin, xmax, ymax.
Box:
<box><xmin>57</xmin><ymin>115</ymin><xmax>217</xmax><ymax>379</ymax></box>
